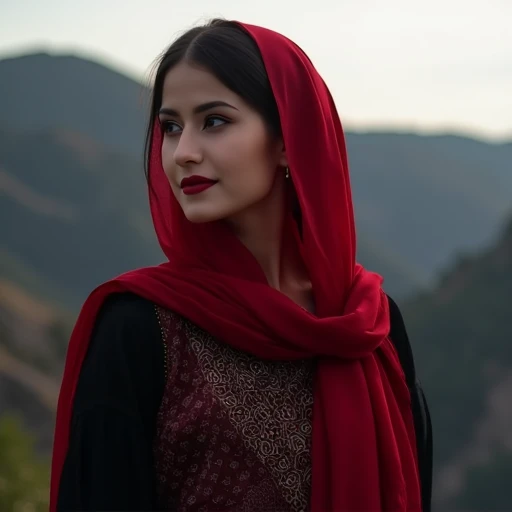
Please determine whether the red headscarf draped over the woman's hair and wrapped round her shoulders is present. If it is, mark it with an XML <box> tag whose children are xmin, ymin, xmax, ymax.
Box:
<box><xmin>51</xmin><ymin>21</ymin><xmax>421</xmax><ymax>512</ymax></box>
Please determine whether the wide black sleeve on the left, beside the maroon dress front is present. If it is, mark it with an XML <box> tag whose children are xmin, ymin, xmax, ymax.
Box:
<box><xmin>57</xmin><ymin>294</ymin><xmax>164</xmax><ymax>512</ymax></box>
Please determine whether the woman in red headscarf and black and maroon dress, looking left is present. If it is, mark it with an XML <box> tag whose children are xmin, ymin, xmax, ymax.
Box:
<box><xmin>51</xmin><ymin>20</ymin><xmax>430</xmax><ymax>511</ymax></box>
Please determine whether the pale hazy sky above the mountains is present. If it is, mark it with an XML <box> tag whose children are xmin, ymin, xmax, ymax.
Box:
<box><xmin>0</xmin><ymin>0</ymin><xmax>512</xmax><ymax>139</ymax></box>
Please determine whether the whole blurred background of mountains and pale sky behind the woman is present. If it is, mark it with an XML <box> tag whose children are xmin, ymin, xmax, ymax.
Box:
<box><xmin>0</xmin><ymin>0</ymin><xmax>512</xmax><ymax>512</ymax></box>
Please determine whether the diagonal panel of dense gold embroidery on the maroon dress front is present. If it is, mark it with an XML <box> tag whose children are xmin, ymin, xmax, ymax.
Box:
<box><xmin>185</xmin><ymin>322</ymin><xmax>314</xmax><ymax>511</ymax></box>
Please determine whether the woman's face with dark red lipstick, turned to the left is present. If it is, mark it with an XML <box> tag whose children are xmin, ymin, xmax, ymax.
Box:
<box><xmin>159</xmin><ymin>62</ymin><xmax>287</xmax><ymax>222</ymax></box>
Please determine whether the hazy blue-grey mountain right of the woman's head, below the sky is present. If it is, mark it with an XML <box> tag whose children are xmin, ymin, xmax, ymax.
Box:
<box><xmin>347</xmin><ymin>133</ymin><xmax>512</xmax><ymax>279</ymax></box>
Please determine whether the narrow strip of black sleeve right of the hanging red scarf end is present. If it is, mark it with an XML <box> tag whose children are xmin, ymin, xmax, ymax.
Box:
<box><xmin>388</xmin><ymin>296</ymin><xmax>433</xmax><ymax>512</ymax></box>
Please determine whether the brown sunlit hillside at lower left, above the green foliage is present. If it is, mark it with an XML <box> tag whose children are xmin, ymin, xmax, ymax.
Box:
<box><xmin>0</xmin><ymin>278</ymin><xmax>62</xmax><ymax>454</ymax></box>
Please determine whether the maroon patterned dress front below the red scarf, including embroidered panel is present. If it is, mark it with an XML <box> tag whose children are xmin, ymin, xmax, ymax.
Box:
<box><xmin>154</xmin><ymin>308</ymin><xmax>314</xmax><ymax>512</ymax></box>
